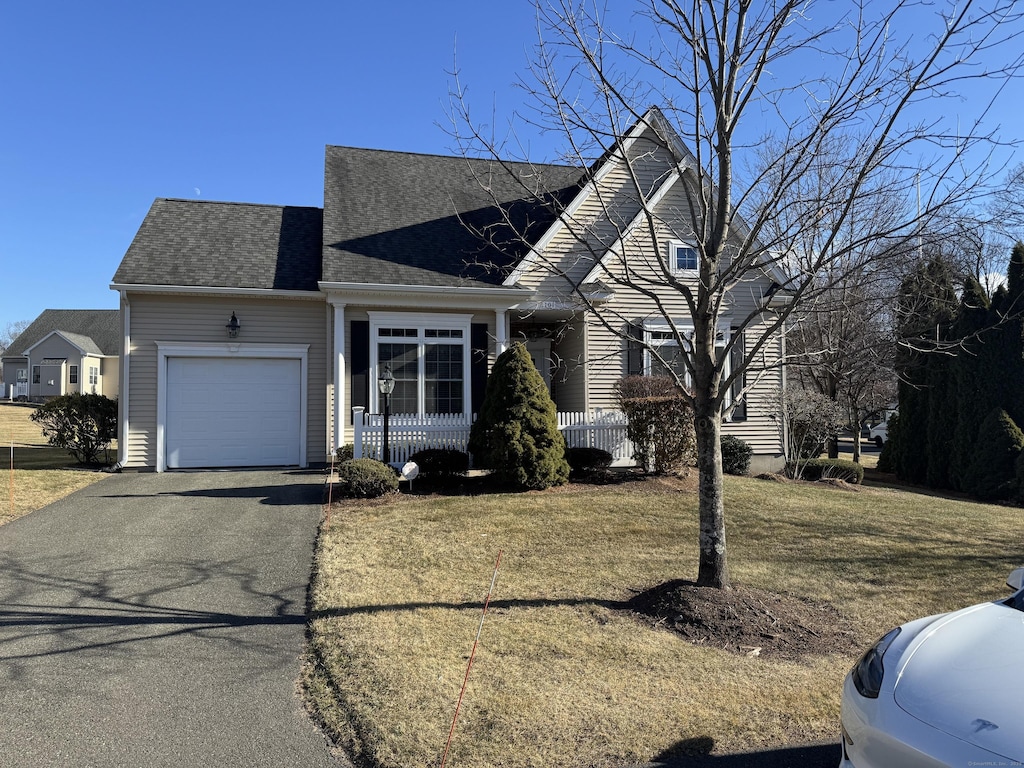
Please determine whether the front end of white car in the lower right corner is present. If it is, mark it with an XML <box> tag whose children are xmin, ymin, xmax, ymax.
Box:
<box><xmin>840</xmin><ymin>568</ymin><xmax>1024</xmax><ymax>768</ymax></box>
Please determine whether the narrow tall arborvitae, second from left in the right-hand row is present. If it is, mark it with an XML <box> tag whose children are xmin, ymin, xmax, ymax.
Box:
<box><xmin>948</xmin><ymin>278</ymin><xmax>995</xmax><ymax>490</ymax></box>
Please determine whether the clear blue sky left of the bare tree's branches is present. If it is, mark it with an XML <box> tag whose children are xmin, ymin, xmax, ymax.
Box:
<box><xmin>0</xmin><ymin>0</ymin><xmax>1020</xmax><ymax>328</ymax></box>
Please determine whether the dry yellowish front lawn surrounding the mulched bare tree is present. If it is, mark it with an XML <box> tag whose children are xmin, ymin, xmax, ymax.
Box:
<box><xmin>308</xmin><ymin>477</ymin><xmax>1024</xmax><ymax>768</ymax></box>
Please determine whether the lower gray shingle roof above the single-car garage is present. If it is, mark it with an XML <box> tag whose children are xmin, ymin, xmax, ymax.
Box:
<box><xmin>114</xmin><ymin>198</ymin><xmax>323</xmax><ymax>291</ymax></box>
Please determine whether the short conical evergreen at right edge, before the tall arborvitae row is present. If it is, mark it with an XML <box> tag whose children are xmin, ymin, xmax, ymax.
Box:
<box><xmin>963</xmin><ymin>408</ymin><xmax>1024</xmax><ymax>500</ymax></box>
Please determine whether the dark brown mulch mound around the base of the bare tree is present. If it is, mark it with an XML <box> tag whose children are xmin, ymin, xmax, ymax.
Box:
<box><xmin>625</xmin><ymin>580</ymin><xmax>862</xmax><ymax>658</ymax></box>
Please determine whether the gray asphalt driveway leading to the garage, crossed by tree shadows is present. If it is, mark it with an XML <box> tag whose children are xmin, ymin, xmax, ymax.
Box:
<box><xmin>0</xmin><ymin>471</ymin><xmax>344</xmax><ymax>768</ymax></box>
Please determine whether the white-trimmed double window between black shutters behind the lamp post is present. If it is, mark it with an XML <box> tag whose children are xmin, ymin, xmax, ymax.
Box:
<box><xmin>370</xmin><ymin>312</ymin><xmax>471</xmax><ymax>416</ymax></box>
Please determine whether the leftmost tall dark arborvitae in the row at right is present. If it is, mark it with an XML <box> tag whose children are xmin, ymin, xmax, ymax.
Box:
<box><xmin>890</xmin><ymin>258</ymin><xmax>956</xmax><ymax>482</ymax></box>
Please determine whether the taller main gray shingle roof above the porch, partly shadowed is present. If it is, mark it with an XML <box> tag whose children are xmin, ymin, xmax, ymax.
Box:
<box><xmin>323</xmin><ymin>146</ymin><xmax>583</xmax><ymax>287</ymax></box>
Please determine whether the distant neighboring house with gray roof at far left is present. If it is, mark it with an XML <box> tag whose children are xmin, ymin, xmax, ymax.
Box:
<box><xmin>3</xmin><ymin>309</ymin><xmax>122</xmax><ymax>401</ymax></box>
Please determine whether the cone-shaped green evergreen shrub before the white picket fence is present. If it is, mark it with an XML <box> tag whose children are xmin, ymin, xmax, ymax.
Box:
<box><xmin>469</xmin><ymin>342</ymin><xmax>569</xmax><ymax>490</ymax></box>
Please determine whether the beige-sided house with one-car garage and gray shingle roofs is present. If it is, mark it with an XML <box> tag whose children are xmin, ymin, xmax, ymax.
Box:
<box><xmin>111</xmin><ymin>105</ymin><xmax>783</xmax><ymax>471</ymax></box>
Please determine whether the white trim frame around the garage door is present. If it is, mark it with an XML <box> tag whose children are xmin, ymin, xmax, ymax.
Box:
<box><xmin>157</xmin><ymin>341</ymin><xmax>309</xmax><ymax>472</ymax></box>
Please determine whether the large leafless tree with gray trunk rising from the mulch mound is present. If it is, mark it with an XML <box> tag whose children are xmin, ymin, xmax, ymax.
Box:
<box><xmin>452</xmin><ymin>0</ymin><xmax>1022</xmax><ymax>588</ymax></box>
